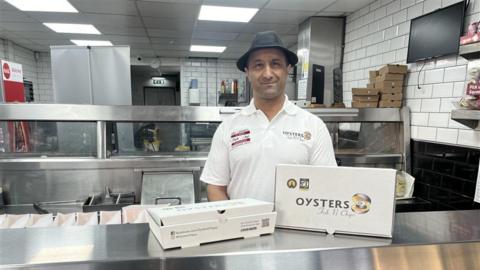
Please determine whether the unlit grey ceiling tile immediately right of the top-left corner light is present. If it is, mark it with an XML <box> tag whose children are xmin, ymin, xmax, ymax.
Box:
<box><xmin>70</xmin><ymin>0</ymin><xmax>138</xmax><ymax>15</ymax></box>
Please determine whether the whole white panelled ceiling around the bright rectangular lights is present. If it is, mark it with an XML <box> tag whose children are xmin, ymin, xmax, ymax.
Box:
<box><xmin>0</xmin><ymin>0</ymin><xmax>374</xmax><ymax>58</ymax></box>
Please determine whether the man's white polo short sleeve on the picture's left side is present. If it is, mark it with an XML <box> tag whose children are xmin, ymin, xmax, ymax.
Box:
<box><xmin>200</xmin><ymin>122</ymin><xmax>230</xmax><ymax>186</ymax></box>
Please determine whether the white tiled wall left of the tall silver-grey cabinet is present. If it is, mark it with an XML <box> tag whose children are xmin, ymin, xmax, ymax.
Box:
<box><xmin>0</xmin><ymin>39</ymin><xmax>53</xmax><ymax>103</ymax></box>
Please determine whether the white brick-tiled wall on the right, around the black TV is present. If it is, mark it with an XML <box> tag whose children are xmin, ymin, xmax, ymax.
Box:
<box><xmin>343</xmin><ymin>0</ymin><xmax>480</xmax><ymax>147</ymax></box>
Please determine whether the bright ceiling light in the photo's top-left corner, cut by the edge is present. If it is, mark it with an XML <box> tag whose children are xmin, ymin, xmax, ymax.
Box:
<box><xmin>5</xmin><ymin>0</ymin><xmax>78</xmax><ymax>13</ymax></box>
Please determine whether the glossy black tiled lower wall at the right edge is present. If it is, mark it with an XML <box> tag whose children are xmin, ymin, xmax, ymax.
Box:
<box><xmin>412</xmin><ymin>141</ymin><xmax>480</xmax><ymax>210</ymax></box>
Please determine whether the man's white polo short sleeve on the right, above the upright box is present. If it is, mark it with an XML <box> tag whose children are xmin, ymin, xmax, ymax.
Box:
<box><xmin>310</xmin><ymin>118</ymin><xmax>337</xmax><ymax>167</ymax></box>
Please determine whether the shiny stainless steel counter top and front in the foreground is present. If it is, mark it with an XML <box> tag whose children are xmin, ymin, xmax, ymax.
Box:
<box><xmin>0</xmin><ymin>210</ymin><xmax>480</xmax><ymax>269</ymax></box>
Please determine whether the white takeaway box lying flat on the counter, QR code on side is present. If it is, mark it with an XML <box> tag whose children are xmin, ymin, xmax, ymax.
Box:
<box><xmin>147</xmin><ymin>199</ymin><xmax>277</xmax><ymax>249</ymax></box>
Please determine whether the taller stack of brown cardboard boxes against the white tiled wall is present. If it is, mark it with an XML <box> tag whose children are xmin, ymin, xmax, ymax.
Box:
<box><xmin>374</xmin><ymin>64</ymin><xmax>407</xmax><ymax>108</ymax></box>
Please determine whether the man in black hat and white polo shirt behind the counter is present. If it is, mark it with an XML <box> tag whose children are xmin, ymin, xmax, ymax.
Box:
<box><xmin>200</xmin><ymin>31</ymin><xmax>337</xmax><ymax>202</ymax></box>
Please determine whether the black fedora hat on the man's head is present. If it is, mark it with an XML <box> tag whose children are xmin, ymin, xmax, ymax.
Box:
<box><xmin>237</xmin><ymin>31</ymin><xmax>298</xmax><ymax>71</ymax></box>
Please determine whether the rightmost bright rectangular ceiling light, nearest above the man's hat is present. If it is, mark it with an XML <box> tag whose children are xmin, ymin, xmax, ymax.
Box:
<box><xmin>198</xmin><ymin>5</ymin><xmax>258</xmax><ymax>22</ymax></box>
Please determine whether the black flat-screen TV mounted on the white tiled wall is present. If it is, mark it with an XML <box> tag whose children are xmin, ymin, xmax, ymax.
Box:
<box><xmin>407</xmin><ymin>1</ymin><xmax>465</xmax><ymax>63</ymax></box>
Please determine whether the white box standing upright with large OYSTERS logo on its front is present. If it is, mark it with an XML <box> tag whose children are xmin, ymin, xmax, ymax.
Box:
<box><xmin>275</xmin><ymin>165</ymin><xmax>396</xmax><ymax>237</ymax></box>
